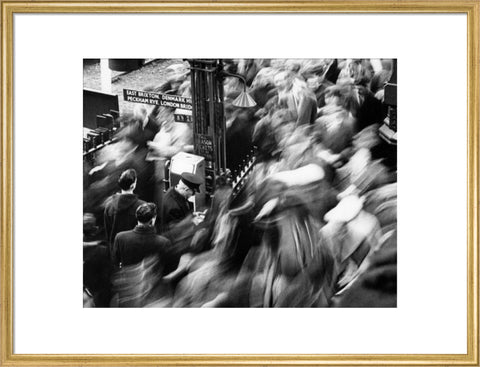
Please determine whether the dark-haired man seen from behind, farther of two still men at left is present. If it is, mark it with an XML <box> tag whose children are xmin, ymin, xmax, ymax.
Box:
<box><xmin>104</xmin><ymin>169</ymin><xmax>145</xmax><ymax>250</ymax></box>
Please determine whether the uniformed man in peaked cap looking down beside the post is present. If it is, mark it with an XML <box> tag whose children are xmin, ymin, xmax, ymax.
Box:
<box><xmin>162</xmin><ymin>172</ymin><xmax>203</xmax><ymax>231</ymax></box>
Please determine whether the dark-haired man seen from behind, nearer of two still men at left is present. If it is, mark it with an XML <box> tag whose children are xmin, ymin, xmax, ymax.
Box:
<box><xmin>113</xmin><ymin>203</ymin><xmax>170</xmax><ymax>267</ymax></box>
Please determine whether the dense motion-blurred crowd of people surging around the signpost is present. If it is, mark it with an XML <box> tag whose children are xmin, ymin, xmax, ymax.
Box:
<box><xmin>83</xmin><ymin>59</ymin><xmax>397</xmax><ymax>307</ymax></box>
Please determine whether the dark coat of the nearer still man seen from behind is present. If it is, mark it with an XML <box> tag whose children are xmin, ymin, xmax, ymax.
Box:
<box><xmin>113</xmin><ymin>226</ymin><xmax>170</xmax><ymax>266</ymax></box>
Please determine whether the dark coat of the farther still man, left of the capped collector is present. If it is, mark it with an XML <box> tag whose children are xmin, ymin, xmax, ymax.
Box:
<box><xmin>104</xmin><ymin>194</ymin><xmax>145</xmax><ymax>250</ymax></box>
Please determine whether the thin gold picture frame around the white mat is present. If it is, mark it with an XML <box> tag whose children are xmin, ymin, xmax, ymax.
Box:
<box><xmin>0</xmin><ymin>0</ymin><xmax>480</xmax><ymax>366</ymax></box>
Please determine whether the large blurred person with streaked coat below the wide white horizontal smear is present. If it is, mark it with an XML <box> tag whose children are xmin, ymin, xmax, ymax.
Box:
<box><xmin>250</xmin><ymin>178</ymin><xmax>335</xmax><ymax>307</ymax></box>
